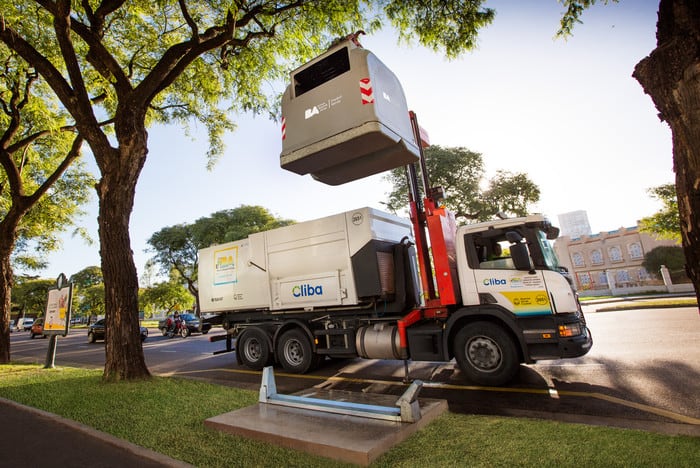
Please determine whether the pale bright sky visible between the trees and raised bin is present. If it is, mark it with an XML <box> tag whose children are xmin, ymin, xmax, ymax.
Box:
<box><xmin>26</xmin><ymin>0</ymin><xmax>674</xmax><ymax>278</ymax></box>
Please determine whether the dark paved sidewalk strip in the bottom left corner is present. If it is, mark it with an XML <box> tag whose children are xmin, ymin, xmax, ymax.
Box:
<box><xmin>0</xmin><ymin>398</ymin><xmax>191</xmax><ymax>468</ymax></box>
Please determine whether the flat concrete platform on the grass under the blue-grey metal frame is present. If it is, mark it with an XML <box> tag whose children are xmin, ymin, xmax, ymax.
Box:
<box><xmin>204</xmin><ymin>389</ymin><xmax>447</xmax><ymax>466</ymax></box>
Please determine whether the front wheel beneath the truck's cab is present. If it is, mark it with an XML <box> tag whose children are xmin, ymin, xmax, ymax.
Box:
<box><xmin>454</xmin><ymin>322</ymin><xmax>520</xmax><ymax>386</ymax></box>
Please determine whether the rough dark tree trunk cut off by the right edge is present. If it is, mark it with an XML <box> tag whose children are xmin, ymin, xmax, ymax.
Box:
<box><xmin>632</xmin><ymin>0</ymin><xmax>700</xmax><ymax>308</ymax></box>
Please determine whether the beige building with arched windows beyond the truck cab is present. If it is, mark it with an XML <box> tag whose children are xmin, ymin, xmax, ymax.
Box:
<box><xmin>554</xmin><ymin>226</ymin><xmax>678</xmax><ymax>295</ymax></box>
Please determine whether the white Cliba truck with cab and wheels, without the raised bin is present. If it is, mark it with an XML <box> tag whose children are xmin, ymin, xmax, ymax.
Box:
<box><xmin>199</xmin><ymin>208</ymin><xmax>591</xmax><ymax>385</ymax></box>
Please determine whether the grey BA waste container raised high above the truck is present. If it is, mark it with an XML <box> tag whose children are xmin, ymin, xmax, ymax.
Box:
<box><xmin>280</xmin><ymin>41</ymin><xmax>419</xmax><ymax>185</ymax></box>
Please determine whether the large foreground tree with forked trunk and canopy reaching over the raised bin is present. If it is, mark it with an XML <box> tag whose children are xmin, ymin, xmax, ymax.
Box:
<box><xmin>0</xmin><ymin>0</ymin><xmax>494</xmax><ymax>380</ymax></box>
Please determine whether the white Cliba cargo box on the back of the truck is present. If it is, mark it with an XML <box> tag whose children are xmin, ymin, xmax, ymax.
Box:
<box><xmin>199</xmin><ymin>207</ymin><xmax>411</xmax><ymax>312</ymax></box>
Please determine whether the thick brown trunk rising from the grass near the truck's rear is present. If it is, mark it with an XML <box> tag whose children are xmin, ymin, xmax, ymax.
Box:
<box><xmin>96</xmin><ymin>134</ymin><xmax>150</xmax><ymax>380</ymax></box>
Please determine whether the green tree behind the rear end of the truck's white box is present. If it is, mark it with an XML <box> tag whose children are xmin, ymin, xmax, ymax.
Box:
<box><xmin>148</xmin><ymin>205</ymin><xmax>292</xmax><ymax>313</ymax></box>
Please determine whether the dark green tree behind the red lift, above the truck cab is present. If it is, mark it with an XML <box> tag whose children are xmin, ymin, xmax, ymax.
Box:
<box><xmin>386</xmin><ymin>145</ymin><xmax>540</xmax><ymax>221</ymax></box>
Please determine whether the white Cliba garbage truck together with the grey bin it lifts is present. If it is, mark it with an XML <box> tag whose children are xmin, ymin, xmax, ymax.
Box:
<box><xmin>198</xmin><ymin>34</ymin><xmax>592</xmax><ymax>386</ymax></box>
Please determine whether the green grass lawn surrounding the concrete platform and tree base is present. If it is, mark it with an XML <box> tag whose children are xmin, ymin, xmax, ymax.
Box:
<box><xmin>0</xmin><ymin>365</ymin><xmax>700</xmax><ymax>467</ymax></box>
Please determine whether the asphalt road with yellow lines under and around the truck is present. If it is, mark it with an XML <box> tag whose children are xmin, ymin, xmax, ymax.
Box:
<box><xmin>6</xmin><ymin>307</ymin><xmax>700</xmax><ymax>435</ymax></box>
